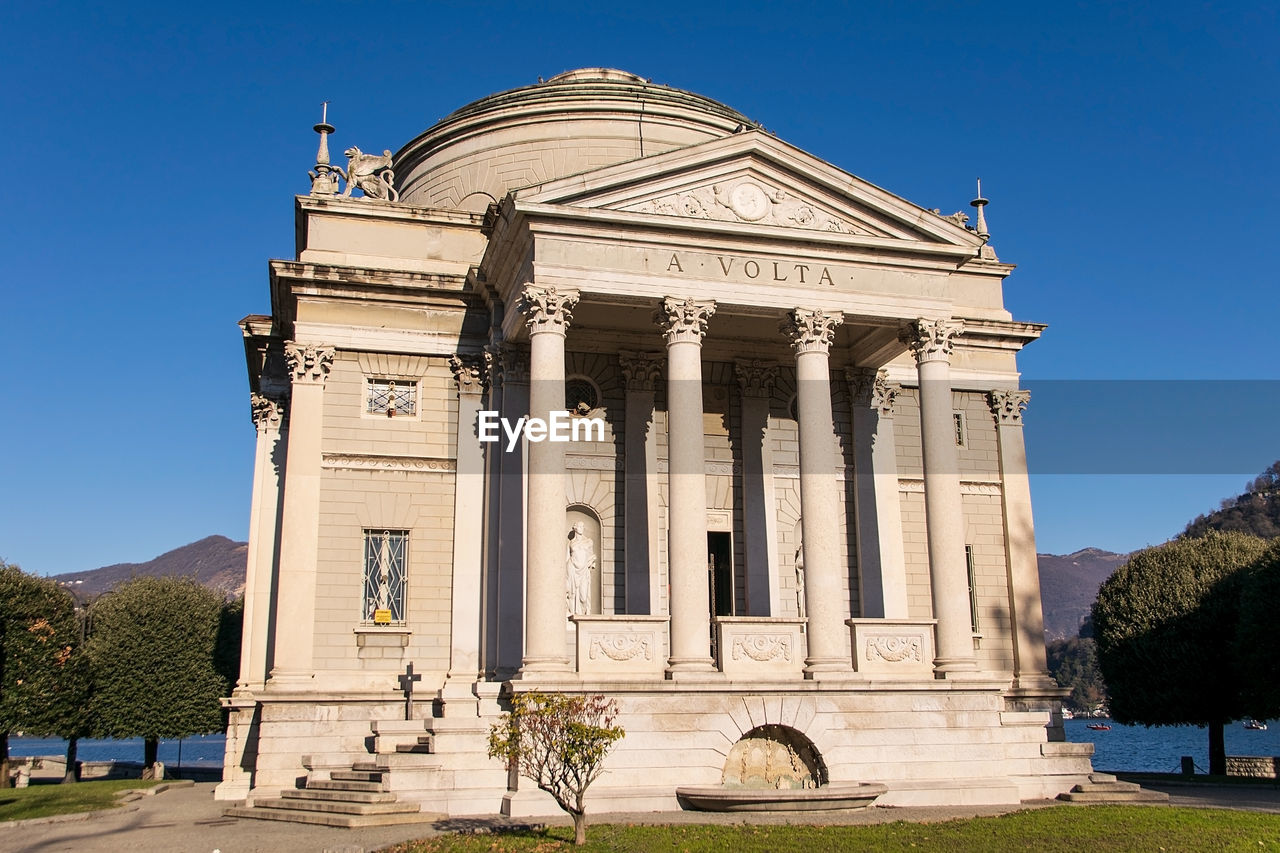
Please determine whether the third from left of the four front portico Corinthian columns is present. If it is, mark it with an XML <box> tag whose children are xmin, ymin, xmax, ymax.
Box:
<box><xmin>782</xmin><ymin>309</ymin><xmax>852</xmax><ymax>679</ymax></box>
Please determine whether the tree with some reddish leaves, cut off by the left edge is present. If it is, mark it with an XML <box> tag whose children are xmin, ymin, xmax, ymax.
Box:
<box><xmin>0</xmin><ymin>561</ymin><xmax>87</xmax><ymax>788</ymax></box>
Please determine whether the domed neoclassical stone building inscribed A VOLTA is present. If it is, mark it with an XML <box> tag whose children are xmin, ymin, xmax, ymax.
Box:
<box><xmin>218</xmin><ymin>69</ymin><xmax>1092</xmax><ymax>821</ymax></box>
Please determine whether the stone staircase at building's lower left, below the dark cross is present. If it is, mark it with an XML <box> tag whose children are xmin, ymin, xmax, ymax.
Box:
<box><xmin>224</xmin><ymin>717</ymin><xmax>506</xmax><ymax>827</ymax></box>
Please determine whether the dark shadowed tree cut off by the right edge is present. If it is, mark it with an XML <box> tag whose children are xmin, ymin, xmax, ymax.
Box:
<box><xmin>1235</xmin><ymin>542</ymin><xmax>1280</xmax><ymax>720</ymax></box>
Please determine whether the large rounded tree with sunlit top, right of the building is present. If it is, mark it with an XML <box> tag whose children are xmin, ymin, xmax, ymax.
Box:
<box><xmin>1093</xmin><ymin>532</ymin><xmax>1267</xmax><ymax>774</ymax></box>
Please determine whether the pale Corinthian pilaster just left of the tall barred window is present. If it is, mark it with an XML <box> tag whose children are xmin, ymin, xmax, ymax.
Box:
<box><xmin>271</xmin><ymin>342</ymin><xmax>334</xmax><ymax>686</ymax></box>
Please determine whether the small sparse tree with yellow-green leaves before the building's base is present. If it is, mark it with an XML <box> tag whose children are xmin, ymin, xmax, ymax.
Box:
<box><xmin>489</xmin><ymin>692</ymin><xmax>625</xmax><ymax>844</ymax></box>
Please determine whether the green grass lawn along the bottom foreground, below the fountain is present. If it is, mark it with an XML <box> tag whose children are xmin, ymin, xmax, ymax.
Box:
<box><xmin>389</xmin><ymin>806</ymin><xmax>1280</xmax><ymax>853</ymax></box>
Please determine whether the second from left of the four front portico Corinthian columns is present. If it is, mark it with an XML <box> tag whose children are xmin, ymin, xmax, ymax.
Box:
<box><xmin>654</xmin><ymin>296</ymin><xmax>716</xmax><ymax>678</ymax></box>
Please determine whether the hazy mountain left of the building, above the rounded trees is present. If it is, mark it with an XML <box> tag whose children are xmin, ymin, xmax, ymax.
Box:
<box><xmin>58</xmin><ymin>537</ymin><xmax>248</xmax><ymax>601</ymax></box>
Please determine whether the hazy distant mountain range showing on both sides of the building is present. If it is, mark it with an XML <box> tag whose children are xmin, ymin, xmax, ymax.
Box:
<box><xmin>58</xmin><ymin>537</ymin><xmax>1129</xmax><ymax>639</ymax></box>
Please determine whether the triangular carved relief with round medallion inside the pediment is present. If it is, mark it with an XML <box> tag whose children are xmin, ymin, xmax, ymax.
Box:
<box><xmin>621</xmin><ymin>178</ymin><xmax>884</xmax><ymax>237</ymax></box>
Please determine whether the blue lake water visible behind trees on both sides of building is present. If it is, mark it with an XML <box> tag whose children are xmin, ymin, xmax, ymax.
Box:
<box><xmin>9</xmin><ymin>720</ymin><xmax>1280</xmax><ymax>774</ymax></box>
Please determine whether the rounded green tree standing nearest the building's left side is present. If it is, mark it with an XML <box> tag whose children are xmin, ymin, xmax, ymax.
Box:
<box><xmin>88</xmin><ymin>578</ymin><xmax>228</xmax><ymax>772</ymax></box>
